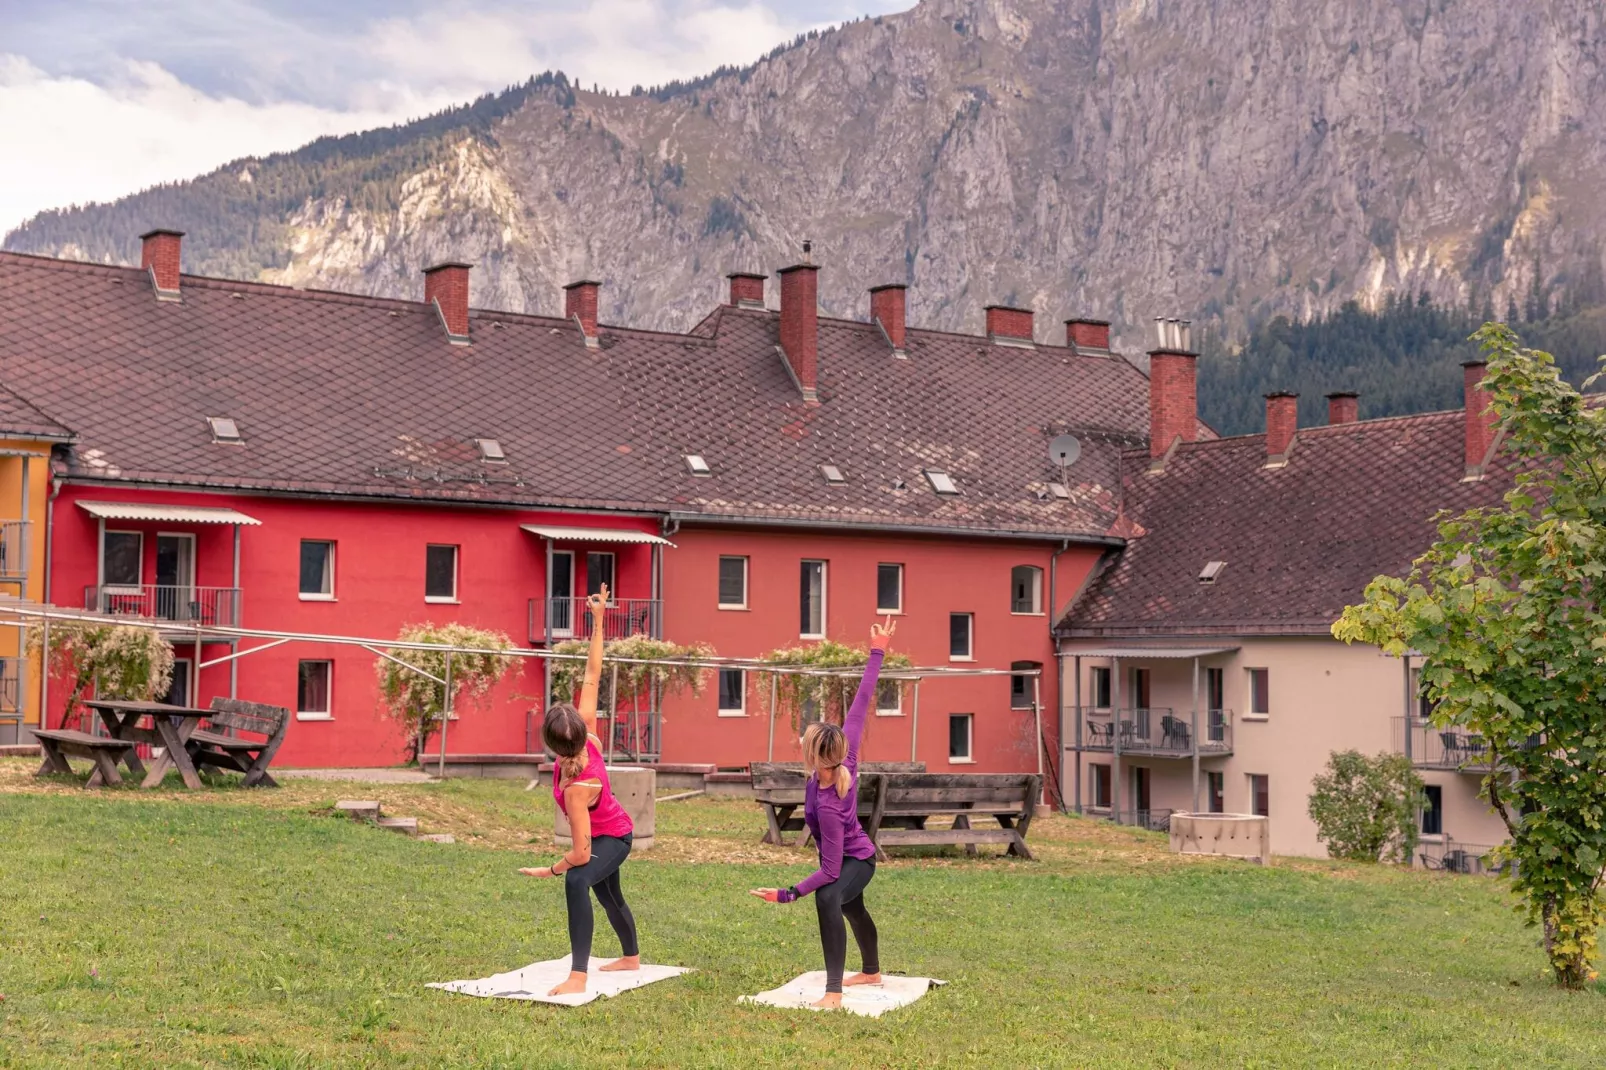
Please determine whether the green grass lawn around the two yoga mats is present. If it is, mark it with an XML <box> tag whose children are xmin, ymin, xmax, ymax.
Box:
<box><xmin>0</xmin><ymin>760</ymin><xmax>1606</xmax><ymax>1070</ymax></box>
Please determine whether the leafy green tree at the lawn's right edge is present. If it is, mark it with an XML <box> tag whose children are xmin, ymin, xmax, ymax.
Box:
<box><xmin>1333</xmin><ymin>323</ymin><xmax>1606</xmax><ymax>988</ymax></box>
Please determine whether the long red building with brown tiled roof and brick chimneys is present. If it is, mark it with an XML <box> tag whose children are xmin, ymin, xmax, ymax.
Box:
<box><xmin>0</xmin><ymin>231</ymin><xmax>1169</xmax><ymax>771</ymax></box>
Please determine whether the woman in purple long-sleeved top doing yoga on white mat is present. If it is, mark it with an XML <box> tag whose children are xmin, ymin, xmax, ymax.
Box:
<box><xmin>752</xmin><ymin>617</ymin><xmax>895</xmax><ymax>1007</ymax></box>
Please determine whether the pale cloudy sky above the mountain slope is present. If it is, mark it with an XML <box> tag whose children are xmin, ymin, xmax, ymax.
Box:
<box><xmin>0</xmin><ymin>0</ymin><xmax>914</xmax><ymax>235</ymax></box>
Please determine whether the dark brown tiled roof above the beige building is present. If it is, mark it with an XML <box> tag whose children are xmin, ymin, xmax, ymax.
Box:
<box><xmin>1060</xmin><ymin>410</ymin><xmax>1511</xmax><ymax>638</ymax></box>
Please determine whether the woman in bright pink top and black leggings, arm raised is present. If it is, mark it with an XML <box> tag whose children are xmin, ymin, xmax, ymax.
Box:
<box><xmin>519</xmin><ymin>583</ymin><xmax>641</xmax><ymax>996</ymax></box>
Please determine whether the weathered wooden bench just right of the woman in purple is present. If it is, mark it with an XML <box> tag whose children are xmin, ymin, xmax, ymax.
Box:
<box><xmin>866</xmin><ymin>773</ymin><xmax>1042</xmax><ymax>860</ymax></box>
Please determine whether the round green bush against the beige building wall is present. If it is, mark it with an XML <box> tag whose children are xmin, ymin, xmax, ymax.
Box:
<box><xmin>1309</xmin><ymin>750</ymin><xmax>1423</xmax><ymax>861</ymax></box>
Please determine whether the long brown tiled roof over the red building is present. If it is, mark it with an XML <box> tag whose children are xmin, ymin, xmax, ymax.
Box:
<box><xmin>0</xmin><ymin>254</ymin><xmax>1148</xmax><ymax>537</ymax></box>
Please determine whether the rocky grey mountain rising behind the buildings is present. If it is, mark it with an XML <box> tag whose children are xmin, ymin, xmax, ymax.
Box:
<box><xmin>5</xmin><ymin>0</ymin><xmax>1606</xmax><ymax>358</ymax></box>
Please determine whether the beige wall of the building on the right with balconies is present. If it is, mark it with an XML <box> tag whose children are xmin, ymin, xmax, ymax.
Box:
<box><xmin>1062</xmin><ymin>636</ymin><xmax>1505</xmax><ymax>858</ymax></box>
